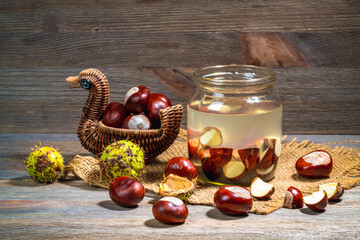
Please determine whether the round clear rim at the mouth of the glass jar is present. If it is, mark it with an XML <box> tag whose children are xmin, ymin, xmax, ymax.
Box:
<box><xmin>194</xmin><ymin>64</ymin><xmax>276</xmax><ymax>86</ymax></box>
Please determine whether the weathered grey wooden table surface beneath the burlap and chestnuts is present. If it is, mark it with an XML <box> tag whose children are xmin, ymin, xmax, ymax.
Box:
<box><xmin>0</xmin><ymin>134</ymin><xmax>360</xmax><ymax>239</ymax></box>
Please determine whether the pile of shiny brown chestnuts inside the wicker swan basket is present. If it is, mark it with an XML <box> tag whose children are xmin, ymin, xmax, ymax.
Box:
<box><xmin>102</xmin><ymin>86</ymin><xmax>171</xmax><ymax>130</ymax></box>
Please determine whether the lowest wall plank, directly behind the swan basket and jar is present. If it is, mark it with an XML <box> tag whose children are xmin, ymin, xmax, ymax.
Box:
<box><xmin>0</xmin><ymin>67</ymin><xmax>360</xmax><ymax>134</ymax></box>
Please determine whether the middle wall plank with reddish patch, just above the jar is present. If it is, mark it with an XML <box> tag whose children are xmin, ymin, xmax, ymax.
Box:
<box><xmin>0</xmin><ymin>31</ymin><xmax>360</xmax><ymax>68</ymax></box>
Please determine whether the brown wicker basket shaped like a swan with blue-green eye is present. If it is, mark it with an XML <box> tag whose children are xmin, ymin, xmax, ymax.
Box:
<box><xmin>66</xmin><ymin>68</ymin><xmax>183</xmax><ymax>159</ymax></box>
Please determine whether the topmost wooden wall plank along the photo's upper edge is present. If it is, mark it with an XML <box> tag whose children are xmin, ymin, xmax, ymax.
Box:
<box><xmin>0</xmin><ymin>0</ymin><xmax>360</xmax><ymax>33</ymax></box>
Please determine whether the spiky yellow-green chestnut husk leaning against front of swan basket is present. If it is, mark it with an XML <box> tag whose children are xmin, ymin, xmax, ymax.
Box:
<box><xmin>100</xmin><ymin>140</ymin><xmax>145</xmax><ymax>181</ymax></box>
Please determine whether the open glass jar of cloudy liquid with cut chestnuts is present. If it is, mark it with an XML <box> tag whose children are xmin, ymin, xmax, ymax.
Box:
<box><xmin>187</xmin><ymin>65</ymin><xmax>282</xmax><ymax>186</ymax></box>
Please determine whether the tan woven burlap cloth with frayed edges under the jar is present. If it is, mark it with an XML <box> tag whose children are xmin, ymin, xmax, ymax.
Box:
<box><xmin>63</xmin><ymin>130</ymin><xmax>360</xmax><ymax>214</ymax></box>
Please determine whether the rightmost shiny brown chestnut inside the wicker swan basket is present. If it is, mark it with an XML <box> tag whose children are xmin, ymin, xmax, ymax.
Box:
<box><xmin>146</xmin><ymin>93</ymin><xmax>171</xmax><ymax>126</ymax></box>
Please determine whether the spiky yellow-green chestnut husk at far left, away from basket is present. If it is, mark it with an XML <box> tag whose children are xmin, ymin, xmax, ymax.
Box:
<box><xmin>25</xmin><ymin>147</ymin><xmax>64</xmax><ymax>183</ymax></box>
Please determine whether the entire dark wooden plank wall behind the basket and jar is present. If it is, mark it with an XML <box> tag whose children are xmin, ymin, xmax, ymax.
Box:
<box><xmin>0</xmin><ymin>0</ymin><xmax>360</xmax><ymax>134</ymax></box>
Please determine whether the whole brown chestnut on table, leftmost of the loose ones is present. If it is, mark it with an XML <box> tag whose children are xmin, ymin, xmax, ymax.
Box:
<box><xmin>109</xmin><ymin>176</ymin><xmax>145</xmax><ymax>207</ymax></box>
